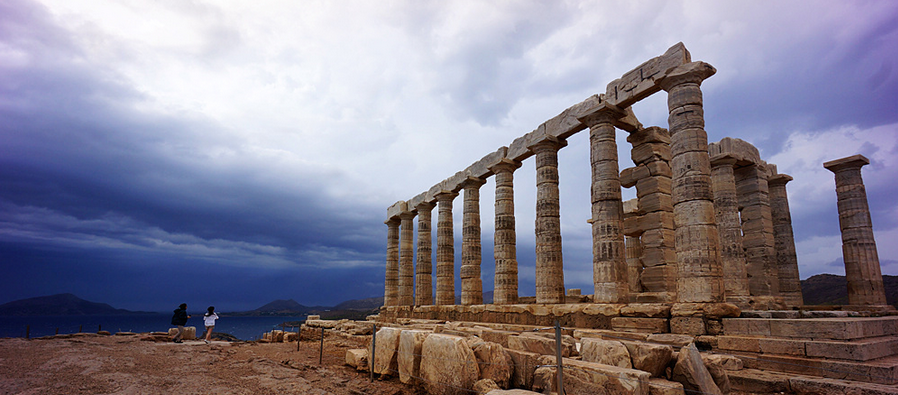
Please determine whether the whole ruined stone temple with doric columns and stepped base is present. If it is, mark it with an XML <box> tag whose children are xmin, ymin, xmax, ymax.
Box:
<box><xmin>366</xmin><ymin>43</ymin><xmax>898</xmax><ymax>394</ymax></box>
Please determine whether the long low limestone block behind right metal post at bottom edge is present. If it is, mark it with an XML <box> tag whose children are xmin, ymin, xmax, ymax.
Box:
<box><xmin>533</xmin><ymin>356</ymin><xmax>650</xmax><ymax>395</ymax></box>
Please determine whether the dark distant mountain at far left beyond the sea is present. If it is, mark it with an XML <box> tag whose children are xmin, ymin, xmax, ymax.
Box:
<box><xmin>0</xmin><ymin>293</ymin><xmax>146</xmax><ymax>316</ymax></box>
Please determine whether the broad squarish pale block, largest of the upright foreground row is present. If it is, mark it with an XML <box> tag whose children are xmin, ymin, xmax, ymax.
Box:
<box><xmin>421</xmin><ymin>334</ymin><xmax>479</xmax><ymax>395</ymax></box>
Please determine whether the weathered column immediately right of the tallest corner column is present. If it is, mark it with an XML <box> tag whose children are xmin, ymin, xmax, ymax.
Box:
<box><xmin>711</xmin><ymin>155</ymin><xmax>750</xmax><ymax>308</ymax></box>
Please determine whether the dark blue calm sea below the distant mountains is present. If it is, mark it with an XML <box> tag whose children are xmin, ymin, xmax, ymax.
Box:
<box><xmin>0</xmin><ymin>313</ymin><xmax>306</xmax><ymax>340</ymax></box>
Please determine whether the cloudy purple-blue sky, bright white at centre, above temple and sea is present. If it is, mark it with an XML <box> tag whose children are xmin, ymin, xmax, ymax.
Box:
<box><xmin>0</xmin><ymin>0</ymin><xmax>898</xmax><ymax>311</ymax></box>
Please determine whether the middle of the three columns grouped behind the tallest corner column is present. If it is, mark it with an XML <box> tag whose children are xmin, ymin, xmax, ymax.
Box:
<box><xmin>734</xmin><ymin>164</ymin><xmax>779</xmax><ymax>297</ymax></box>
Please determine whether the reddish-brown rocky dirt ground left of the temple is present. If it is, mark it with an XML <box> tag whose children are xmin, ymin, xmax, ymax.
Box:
<box><xmin>0</xmin><ymin>334</ymin><xmax>420</xmax><ymax>395</ymax></box>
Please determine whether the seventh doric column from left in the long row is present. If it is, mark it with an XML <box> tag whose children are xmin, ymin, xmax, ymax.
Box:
<box><xmin>530</xmin><ymin>136</ymin><xmax>567</xmax><ymax>303</ymax></box>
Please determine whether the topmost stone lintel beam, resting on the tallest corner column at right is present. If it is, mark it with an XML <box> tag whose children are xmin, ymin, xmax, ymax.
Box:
<box><xmin>605</xmin><ymin>43</ymin><xmax>692</xmax><ymax>108</ymax></box>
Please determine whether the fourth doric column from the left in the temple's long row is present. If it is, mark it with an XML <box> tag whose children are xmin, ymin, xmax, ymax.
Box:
<box><xmin>436</xmin><ymin>191</ymin><xmax>458</xmax><ymax>305</ymax></box>
